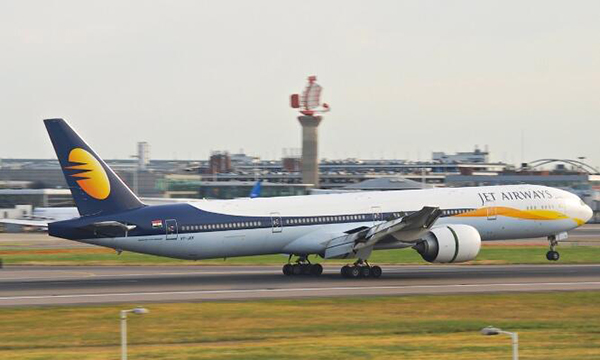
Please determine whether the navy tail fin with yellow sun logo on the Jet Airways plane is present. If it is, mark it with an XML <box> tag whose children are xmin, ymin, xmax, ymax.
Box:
<box><xmin>44</xmin><ymin>119</ymin><xmax>145</xmax><ymax>216</ymax></box>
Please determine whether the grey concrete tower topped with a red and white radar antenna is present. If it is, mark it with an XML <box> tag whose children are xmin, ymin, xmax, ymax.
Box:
<box><xmin>291</xmin><ymin>76</ymin><xmax>329</xmax><ymax>188</ymax></box>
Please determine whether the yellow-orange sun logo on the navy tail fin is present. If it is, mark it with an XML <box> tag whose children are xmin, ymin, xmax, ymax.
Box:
<box><xmin>66</xmin><ymin>148</ymin><xmax>110</xmax><ymax>200</ymax></box>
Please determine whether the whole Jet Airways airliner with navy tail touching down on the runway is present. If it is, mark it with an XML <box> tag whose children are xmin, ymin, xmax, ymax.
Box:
<box><xmin>44</xmin><ymin>119</ymin><xmax>592</xmax><ymax>278</ymax></box>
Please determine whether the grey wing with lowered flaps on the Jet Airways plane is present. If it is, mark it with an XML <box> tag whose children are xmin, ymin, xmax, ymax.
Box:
<box><xmin>324</xmin><ymin>206</ymin><xmax>442</xmax><ymax>259</ymax></box>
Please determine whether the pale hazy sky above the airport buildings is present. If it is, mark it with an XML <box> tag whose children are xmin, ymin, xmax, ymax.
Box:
<box><xmin>0</xmin><ymin>0</ymin><xmax>600</xmax><ymax>167</ymax></box>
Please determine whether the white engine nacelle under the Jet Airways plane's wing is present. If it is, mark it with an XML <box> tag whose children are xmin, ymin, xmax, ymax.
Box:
<box><xmin>413</xmin><ymin>225</ymin><xmax>481</xmax><ymax>263</ymax></box>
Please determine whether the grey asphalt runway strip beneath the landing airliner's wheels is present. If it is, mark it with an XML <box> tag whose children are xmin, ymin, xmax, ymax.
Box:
<box><xmin>0</xmin><ymin>264</ymin><xmax>600</xmax><ymax>306</ymax></box>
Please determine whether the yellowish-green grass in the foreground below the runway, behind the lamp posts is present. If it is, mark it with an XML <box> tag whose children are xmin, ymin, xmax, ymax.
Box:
<box><xmin>0</xmin><ymin>292</ymin><xmax>600</xmax><ymax>360</ymax></box>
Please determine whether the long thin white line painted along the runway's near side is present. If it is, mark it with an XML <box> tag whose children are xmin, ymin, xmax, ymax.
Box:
<box><xmin>0</xmin><ymin>281</ymin><xmax>600</xmax><ymax>301</ymax></box>
